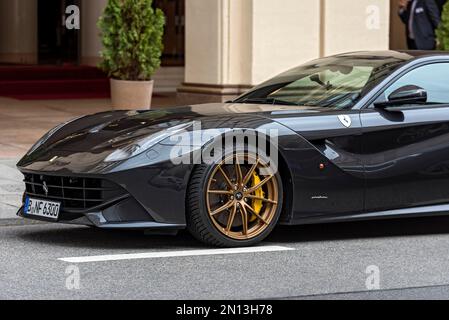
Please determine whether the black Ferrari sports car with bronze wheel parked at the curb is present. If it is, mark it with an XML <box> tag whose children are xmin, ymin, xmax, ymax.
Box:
<box><xmin>18</xmin><ymin>51</ymin><xmax>449</xmax><ymax>247</ymax></box>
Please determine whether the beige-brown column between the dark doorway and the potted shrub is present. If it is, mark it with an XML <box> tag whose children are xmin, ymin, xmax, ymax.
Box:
<box><xmin>81</xmin><ymin>0</ymin><xmax>107</xmax><ymax>66</ymax></box>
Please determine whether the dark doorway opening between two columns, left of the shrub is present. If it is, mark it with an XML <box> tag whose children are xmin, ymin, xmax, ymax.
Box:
<box><xmin>38</xmin><ymin>0</ymin><xmax>81</xmax><ymax>65</ymax></box>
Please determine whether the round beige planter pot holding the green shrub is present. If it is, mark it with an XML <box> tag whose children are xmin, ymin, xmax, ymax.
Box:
<box><xmin>111</xmin><ymin>79</ymin><xmax>154</xmax><ymax>110</ymax></box>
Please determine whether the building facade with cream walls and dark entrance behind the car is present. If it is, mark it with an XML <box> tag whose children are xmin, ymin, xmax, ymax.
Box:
<box><xmin>0</xmin><ymin>0</ymin><xmax>424</xmax><ymax>102</ymax></box>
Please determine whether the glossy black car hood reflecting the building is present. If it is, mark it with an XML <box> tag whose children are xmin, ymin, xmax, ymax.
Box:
<box><xmin>18</xmin><ymin>103</ymin><xmax>324</xmax><ymax>171</ymax></box>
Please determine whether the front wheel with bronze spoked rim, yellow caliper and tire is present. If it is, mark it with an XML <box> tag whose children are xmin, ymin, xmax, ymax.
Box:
<box><xmin>187</xmin><ymin>152</ymin><xmax>283</xmax><ymax>247</ymax></box>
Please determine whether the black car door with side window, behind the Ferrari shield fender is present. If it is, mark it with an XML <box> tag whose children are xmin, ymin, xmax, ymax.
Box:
<box><xmin>360</xmin><ymin>62</ymin><xmax>449</xmax><ymax>212</ymax></box>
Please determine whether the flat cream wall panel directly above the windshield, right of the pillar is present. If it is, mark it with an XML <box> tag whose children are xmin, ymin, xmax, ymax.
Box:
<box><xmin>251</xmin><ymin>0</ymin><xmax>322</xmax><ymax>85</ymax></box>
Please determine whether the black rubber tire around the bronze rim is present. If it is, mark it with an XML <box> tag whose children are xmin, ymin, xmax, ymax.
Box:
<box><xmin>186</xmin><ymin>153</ymin><xmax>283</xmax><ymax>248</ymax></box>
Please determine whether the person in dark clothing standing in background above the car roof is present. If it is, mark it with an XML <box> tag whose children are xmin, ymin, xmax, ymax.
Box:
<box><xmin>399</xmin><ymin>0</ymin><xmax>441</xmax><ymax>50</ymax></box>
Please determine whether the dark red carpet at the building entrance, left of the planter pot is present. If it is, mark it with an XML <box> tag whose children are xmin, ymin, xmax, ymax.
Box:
<box><xmin>0</xmin><ymin>66</ymin><xmax>110</xmax><ymax>100</ymax></box>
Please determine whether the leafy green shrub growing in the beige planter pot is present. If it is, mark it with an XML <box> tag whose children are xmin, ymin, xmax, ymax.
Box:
<box><xmin>98</xmin><ymin>0</ymin><xmax>165</xmax><ymax>81</ymax></box>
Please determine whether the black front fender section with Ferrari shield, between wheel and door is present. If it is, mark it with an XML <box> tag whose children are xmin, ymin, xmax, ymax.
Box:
<box><xmin>272</xmin><ymin>108</ymin><xmax>364</xmax><ymax>218</ymax></box>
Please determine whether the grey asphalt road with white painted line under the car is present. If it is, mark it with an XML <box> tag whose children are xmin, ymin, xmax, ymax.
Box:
<box><xmin>0</xmin><ymin>217</ymin><xmax>449</xmax><ymax>299</ymax></box>
